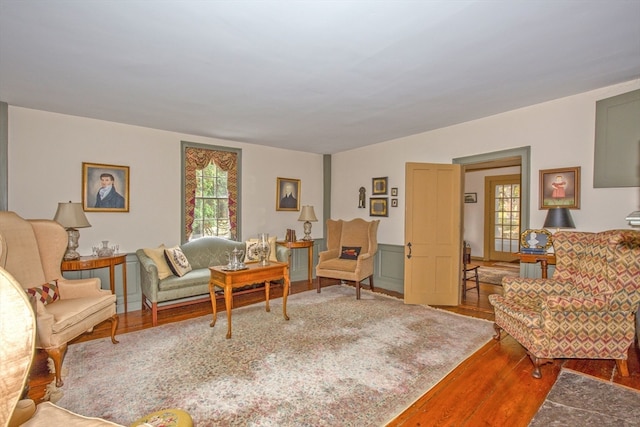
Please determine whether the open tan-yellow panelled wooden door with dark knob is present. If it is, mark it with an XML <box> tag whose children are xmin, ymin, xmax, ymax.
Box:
<box><xmin>404</xmin><ymin>163</ymin><xmax>462</xmax><ymax>305</ymax></box>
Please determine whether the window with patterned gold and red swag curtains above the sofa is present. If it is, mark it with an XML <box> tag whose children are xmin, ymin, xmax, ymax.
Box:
<box><xmin>182</xmin><ymin>142</ymin><xmax>241</xmax><ymax>242</ymax></box>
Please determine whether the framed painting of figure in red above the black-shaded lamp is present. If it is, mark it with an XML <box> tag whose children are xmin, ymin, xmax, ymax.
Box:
<box><xmin>540</xmin><ymin>166</ymin><xmax>580</xmax><ymax>209</ymax></box>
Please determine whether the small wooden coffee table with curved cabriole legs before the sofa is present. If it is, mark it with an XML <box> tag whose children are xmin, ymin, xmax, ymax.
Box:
<box><xmin>209</xmin><ymin>262</ymin><xmax>289</xmax><ymax>339</ymax></box>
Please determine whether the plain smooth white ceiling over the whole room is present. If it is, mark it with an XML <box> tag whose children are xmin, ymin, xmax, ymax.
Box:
<box><xmin>0</xmin><ymin>0</ymin><xmax>640</xmax><ymax>154</ymax></box>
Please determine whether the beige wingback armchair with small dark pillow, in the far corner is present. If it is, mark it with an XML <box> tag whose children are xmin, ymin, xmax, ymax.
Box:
<box><xmin>316</xmin><ymin>218</ymin><xmax>380</xmax><ymax>299</ymax></box>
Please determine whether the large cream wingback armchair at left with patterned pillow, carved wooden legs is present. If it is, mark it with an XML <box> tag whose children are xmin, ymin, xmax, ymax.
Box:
<box><xmin>0</xmin><ymin>212</ymin><xmax>118</xmax><ymax>387</ymax></box>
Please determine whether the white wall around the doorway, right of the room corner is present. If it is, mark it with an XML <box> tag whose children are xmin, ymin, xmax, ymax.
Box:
<box><xmin>331</xmin><ymin>80</ymin><xmax>640</xmax><ymax>245</ymax></box>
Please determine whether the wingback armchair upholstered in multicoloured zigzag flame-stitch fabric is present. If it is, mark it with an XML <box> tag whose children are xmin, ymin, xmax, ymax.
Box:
<box><xmin>489</xmin><ymin>230</ymin><xmax>640</xmax><ymax>378</ymax></box>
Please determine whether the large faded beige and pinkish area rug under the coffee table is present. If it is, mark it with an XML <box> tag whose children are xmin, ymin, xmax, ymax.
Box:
<box><xmin>58</xmin><ymin>285</ymin><xmax>493</xmax><ymax>427</ymax></box>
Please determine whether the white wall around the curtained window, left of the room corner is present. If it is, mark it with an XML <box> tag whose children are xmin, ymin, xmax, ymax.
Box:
<box><xmin>8</xmin><ymin>106</ymin><xmax>324</xmax><ymax>255</ymax></box>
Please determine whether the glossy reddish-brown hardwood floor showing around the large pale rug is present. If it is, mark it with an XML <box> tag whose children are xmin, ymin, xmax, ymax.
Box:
<box><xmin>29</xmin><ymin>270</ymin><xmax>640</xmax><ymax>427</ymax></box>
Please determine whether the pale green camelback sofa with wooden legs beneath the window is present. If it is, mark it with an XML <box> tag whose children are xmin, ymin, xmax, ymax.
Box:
<box><xmin>136</xmin><ymin>237</ymin><xmax>289</xmax><ymax>326</ymax></box>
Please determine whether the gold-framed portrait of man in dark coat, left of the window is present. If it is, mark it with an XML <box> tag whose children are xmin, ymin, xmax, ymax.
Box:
<box><xmin>82</xmin><ymin>162</ymin><xmax>129</xmax><ymax>212</ymax></box>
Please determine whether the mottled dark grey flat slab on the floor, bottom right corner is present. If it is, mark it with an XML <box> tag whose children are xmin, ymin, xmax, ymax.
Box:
<box><xmin>529</xmin><ymin>369</ymin><xmax>640</xmax><ymax>427</ymax></box>
